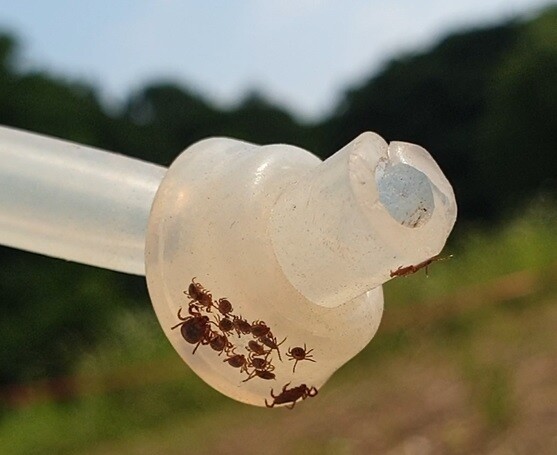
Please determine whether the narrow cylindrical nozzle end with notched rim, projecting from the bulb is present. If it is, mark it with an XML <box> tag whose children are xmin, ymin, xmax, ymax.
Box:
<box><xmin>270</xmin><ymin>133</ymin><xmax>456</xmax><ymax>307</ymax></box>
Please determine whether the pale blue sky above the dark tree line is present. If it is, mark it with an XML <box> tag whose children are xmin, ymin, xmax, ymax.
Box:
<box><xmin>0</xmin><ymin>0</ymin><xmax>553</xmax><ymax>117</ymax></box>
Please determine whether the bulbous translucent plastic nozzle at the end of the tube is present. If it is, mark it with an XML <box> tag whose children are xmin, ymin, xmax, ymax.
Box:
<box><xmin>146</xmin><ymin>133</ymin><xmax>456</xmax><ymax>406</ymax></box>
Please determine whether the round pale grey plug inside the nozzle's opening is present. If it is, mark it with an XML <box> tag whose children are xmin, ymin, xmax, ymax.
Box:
<box><xmin>375</xmin><ymin>162</ymin><xmax>435</xmax><ymax>228</ymax></box>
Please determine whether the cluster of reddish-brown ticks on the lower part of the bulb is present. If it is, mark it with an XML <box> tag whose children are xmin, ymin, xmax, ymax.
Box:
<box><xmin>172</xmin><ymin>278</ymin><xmax>317</xmax><ymax>408</ymax></box>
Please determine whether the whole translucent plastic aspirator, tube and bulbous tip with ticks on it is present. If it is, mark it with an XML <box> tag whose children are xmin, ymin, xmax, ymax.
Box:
<box><xmin>0</xmin><ymin>128</ymin><xmax>457</xmax><ymax>407</ymax></box>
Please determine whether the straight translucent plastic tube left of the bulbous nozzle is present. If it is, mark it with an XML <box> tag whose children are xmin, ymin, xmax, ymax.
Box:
<box><xmin>0</xmin><ymin>127</ymin><xmax>166</xmax><ymax>275</ymax></box>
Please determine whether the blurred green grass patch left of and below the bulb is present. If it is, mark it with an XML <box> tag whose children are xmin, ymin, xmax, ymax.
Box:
<box><xmin>0</xmin><ymin>309</ymin><xmax>232</xmax><ymax>455</ymax></box>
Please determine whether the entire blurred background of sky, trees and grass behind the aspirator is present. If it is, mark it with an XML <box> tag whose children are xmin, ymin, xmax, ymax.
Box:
<box><xmin>0</xmin><ymin>0</ymin><xmax>557</xmax><ymax>455</ymax></box>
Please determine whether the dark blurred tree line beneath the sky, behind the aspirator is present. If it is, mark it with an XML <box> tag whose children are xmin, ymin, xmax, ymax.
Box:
<box><xmin>0</xmin><ymin>7</ymin><xmax>557</xmax><ymax>384</ymax></box>
